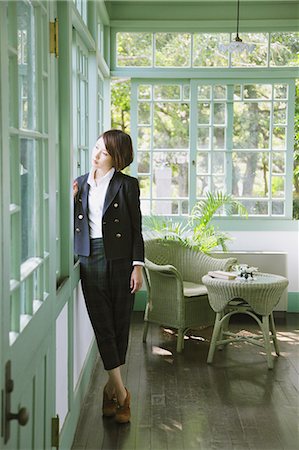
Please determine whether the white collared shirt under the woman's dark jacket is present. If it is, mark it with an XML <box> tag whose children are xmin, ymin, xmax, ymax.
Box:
<box><xmin>87</xmin><ymin>167</ymin><xmax>115</xmax><ymax>239</ymax></box>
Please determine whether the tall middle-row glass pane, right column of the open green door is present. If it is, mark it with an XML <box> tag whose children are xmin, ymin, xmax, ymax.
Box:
<box><xmin>20</xmin><ymin>139</ymin><xmax>39</xmax><ymax>263</ymax></box>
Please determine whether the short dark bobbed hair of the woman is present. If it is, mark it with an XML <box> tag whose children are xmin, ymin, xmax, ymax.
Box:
<box><xmin>99</xmin><ymin>130</ymin><xmax>134</xmax><ymax>172</ymax></box>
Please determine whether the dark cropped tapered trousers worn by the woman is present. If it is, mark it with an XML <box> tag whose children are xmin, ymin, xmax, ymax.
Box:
<box><xmin>80</xmin><ymin>238</ymin><xmax>134</xmax><ymax>370</ymax></box>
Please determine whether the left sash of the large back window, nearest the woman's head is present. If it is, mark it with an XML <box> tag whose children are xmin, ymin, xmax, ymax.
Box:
<box><xmin>137</xmin><ymin>83</ymin><xmax>190</xmax><ymax>215</ymax></box>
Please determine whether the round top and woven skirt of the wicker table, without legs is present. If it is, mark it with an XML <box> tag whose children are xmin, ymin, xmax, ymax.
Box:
<box><xmin>202</xmin><ymin>273</ymin><xmax>289</xmax><ymax>315</ymax></box>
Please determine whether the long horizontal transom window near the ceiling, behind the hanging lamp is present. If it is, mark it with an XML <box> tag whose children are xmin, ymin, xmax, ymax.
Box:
<box><xmin>115</xmin><ymin>32</ymin><xmax>299</xmax><ymax>68</ymax></box>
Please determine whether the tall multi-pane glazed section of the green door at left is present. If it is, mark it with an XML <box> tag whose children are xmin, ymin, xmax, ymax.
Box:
<box><xmin>8</xmin><ymin>1</ymin><xmax>49</xmax><ymax>344</ymax></box>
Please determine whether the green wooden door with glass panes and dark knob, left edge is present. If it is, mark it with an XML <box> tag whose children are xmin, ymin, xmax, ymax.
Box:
<box><xmin>0</xmin><ymin>1</ymin><xmax>57</xmax><ymax>450</ymax></box>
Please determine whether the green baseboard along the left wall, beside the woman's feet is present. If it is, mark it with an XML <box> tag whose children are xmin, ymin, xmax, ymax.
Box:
<box><xmin>59</xmin><ymin>342</ymin><xmax>97</xmax><ymax>449</ymax></box>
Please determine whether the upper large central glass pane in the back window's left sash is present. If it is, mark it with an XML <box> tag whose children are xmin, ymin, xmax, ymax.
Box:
<box><xmin>153</xmin><ymin>102</ymin><xmax>189</xmax><ymax>148</ymax></box>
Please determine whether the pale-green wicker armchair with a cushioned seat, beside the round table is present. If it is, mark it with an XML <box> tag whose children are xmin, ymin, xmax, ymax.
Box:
<box><xmin>143</xmin><ymin>239</ymin><xmax>237</xmax><ymax>352</ymax></box>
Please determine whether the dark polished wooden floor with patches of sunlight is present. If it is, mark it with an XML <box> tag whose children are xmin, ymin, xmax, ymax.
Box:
<box><xmin>72</xmin><ymin>312</ymin><xmax>299</xmax><ymax>450</ymax></box>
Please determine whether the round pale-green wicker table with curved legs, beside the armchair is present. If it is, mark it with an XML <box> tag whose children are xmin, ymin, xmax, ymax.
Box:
<box><xmin>202</xmin><ymin>273</ymin><xmax>289</xmax><ymax>369</ymax></box>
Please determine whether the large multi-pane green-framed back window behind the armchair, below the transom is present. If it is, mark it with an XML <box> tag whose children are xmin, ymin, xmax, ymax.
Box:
<box><xmin>132</xmin><ymin>80</ymin><xmax>294</xmax><ymax>217</ymax></box>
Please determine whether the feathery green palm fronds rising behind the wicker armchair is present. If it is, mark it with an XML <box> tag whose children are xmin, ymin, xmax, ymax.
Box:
<box><xmin>143</xmin><ymin>192</ymin><xmax>247</xmax><ymax>253</ymax></box>
